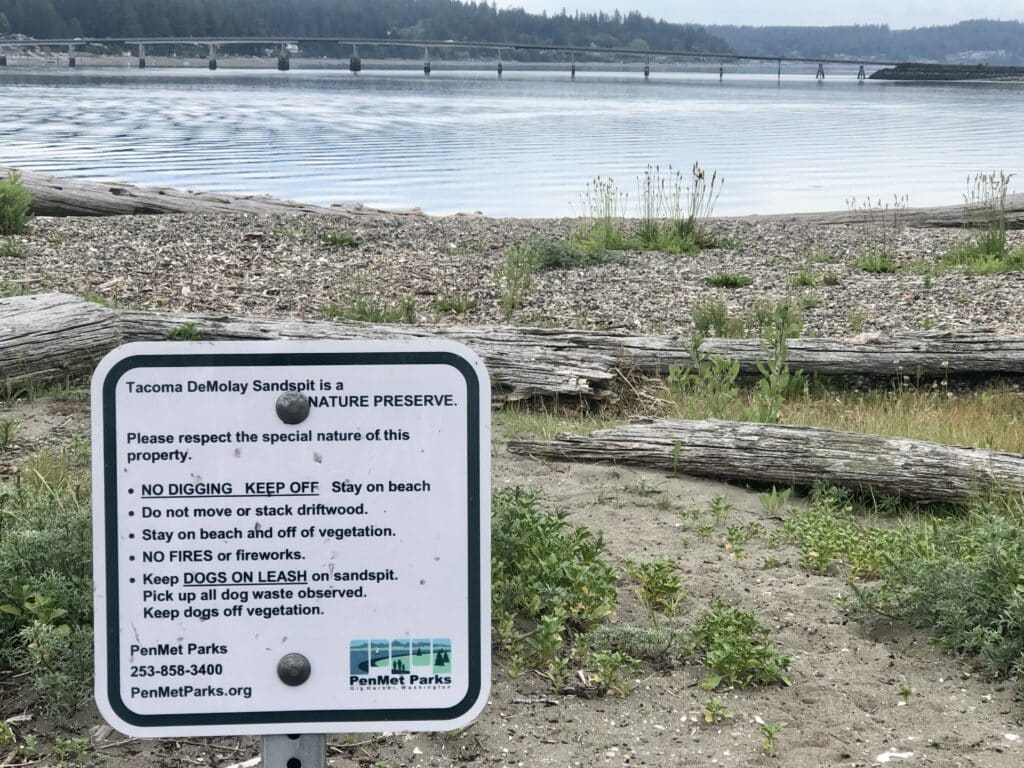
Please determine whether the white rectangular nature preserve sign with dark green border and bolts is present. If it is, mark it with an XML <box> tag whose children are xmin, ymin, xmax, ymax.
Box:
<box><xmin>92</xmin><ymin>341</ymin><xmax>490</xmax><ymax>736</ymax></box>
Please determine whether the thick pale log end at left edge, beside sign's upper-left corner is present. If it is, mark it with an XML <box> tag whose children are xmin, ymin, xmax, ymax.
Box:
<box><xmin>0</xmin><ymin>293</ymin><xmax>121</xmax><ymax>391</ymax></box>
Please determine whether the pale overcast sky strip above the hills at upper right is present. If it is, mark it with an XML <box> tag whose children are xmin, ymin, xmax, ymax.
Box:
<box><xmin>497</xmin><ymin>0</ymin><xmax>1024</xmax><ymax>29</ymax></box>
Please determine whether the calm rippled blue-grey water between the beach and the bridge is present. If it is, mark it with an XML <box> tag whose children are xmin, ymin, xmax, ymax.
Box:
<box><xmin>0</xmin><ymin>69</ymin><xmax>1024</xmax><ymax>216</ymax></box>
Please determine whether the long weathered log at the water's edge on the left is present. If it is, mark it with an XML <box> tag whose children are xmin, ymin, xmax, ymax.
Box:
<box><xmin>0</xmin><ymin>166</ymin><xmax>422</xmax><ymax>216</ymax></box>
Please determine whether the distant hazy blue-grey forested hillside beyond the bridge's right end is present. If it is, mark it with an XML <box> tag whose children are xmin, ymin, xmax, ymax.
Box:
<box><xmin>708</xmin><ymin>19</ymin><xmax>1024</xmax><ymax>63</ymax></box>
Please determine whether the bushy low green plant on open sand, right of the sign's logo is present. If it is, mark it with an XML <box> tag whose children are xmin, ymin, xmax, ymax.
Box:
<box><xmin>693</xmin><ymin>600</ymin><xmax>791</xmax><ymax>690</ymax></box>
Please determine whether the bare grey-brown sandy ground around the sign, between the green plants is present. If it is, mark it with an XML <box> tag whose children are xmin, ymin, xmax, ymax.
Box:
<box><xmin>0</xmin><ymin>399</ymin><xmax>1024</xmax><ymax>768</ymax></box>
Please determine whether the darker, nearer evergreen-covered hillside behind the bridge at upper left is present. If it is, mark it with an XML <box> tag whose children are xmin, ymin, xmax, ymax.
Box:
<box><xmin>0</xmin><ymin>0</ymin><xmax>728</xmax><ymax>51</ymax></box>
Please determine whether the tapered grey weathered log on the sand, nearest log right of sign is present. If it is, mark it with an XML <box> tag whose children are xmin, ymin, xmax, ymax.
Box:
<box><xmin>509</xmin><ymin>421</ymin><xmax>1024</xmax><ymax>503</ymax></box>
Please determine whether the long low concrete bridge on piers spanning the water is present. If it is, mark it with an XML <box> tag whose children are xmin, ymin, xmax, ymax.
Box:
<box><xmin>0</xmin><ymin>37</ymin><xmax>906</xmax><ymax>79</ymax></box>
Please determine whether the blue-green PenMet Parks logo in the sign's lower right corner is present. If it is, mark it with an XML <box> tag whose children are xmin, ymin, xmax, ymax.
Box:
<box><xmin>348</xmin><ymin>637</ymin><xmax>452</xmax><ymax>690</ymax></box>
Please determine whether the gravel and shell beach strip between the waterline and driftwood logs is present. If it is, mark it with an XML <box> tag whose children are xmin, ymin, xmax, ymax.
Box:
<box><xmin>0</xmin><ymin>214</ymin><xmax>1024</xmax><ymax>336</ymax></box>
